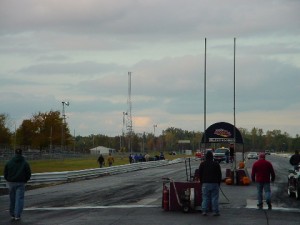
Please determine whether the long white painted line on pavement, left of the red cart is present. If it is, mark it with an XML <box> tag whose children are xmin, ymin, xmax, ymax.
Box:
<box><xmin>24</xmin><ymin>205</ymin><xmax>161</xmax><ymax>211</ymax></box>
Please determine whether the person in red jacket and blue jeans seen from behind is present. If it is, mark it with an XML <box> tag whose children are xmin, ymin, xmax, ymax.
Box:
<box><xmin>251</xmin><ymin>153</ymin><xmax>275</xmax><ymax>209</ymax></box>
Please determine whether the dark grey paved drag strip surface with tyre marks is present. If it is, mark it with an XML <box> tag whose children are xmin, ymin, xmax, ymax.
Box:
<box><xmin>0</xmin><ymin>156</ymin><xmax>300</xmax><ymax>225</ymax></box>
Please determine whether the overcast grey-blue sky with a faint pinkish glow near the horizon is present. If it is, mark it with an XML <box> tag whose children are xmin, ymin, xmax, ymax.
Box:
<box><xmin>0</xmin><ymin>0</ymin><xmax>300</xmax><ymax>137</ymax></box>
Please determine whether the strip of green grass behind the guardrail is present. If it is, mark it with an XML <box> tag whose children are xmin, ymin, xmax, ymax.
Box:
<box><xmin>0</xmin><ymin>153</ymin><xmax>186</xmax><ymax>175</ymax></box>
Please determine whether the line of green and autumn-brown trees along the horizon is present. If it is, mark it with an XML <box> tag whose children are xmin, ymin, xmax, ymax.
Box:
<box><xmin>0</xmin><ymin>111</ymin><xmax>300</xmax><ymax>153</ymax></box>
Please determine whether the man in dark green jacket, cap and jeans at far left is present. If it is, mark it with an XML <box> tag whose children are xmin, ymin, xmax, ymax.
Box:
<box><xmin>4</xmin><ymin>149</ymin><xmax>31</xmax><ymax>220</ymax></box>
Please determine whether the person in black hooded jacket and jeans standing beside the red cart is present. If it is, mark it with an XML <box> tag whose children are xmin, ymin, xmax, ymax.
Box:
<box><xmin>199</xmin><ymin>151</ymin><xmax>222</xmax><ymax>216</ymax></box>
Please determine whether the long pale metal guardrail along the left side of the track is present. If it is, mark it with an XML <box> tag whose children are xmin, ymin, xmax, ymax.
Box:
<box><xmin>0</xmin><ymin>159</ymin><xmax>183</xmax><ymax>189</ymax></box>
